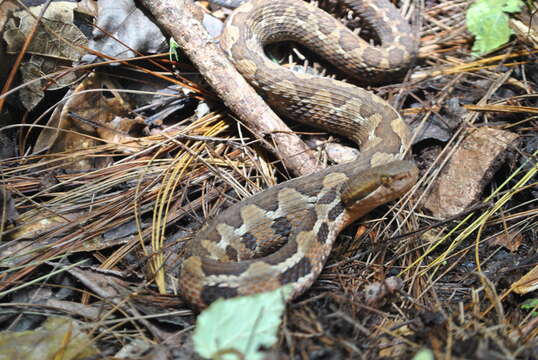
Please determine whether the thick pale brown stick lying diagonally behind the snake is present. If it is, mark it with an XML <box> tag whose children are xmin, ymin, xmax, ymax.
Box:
<box><xmin>141</xmin><ymin>0</ymin><xmax>320</xmax><ymax>175</ymax></box>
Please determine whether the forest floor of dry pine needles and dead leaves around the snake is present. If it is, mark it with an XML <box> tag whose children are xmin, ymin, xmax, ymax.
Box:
<box><xmin>0</xmin><ymin>0</ymin><xmax>538</xmax><ymax>359</ymax></box>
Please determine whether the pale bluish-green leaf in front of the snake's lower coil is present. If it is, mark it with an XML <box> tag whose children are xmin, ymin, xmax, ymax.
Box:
<box><xmin>193</xmin><ymin>286</ymin><xmax>292</xmax><ymax>360</ymax></box>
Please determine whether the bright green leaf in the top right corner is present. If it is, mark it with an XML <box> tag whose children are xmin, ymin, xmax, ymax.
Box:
<box><xmin>467</xmin><ymin>0</ymin><xmax>523</xmax><ymax>55</ymax></box>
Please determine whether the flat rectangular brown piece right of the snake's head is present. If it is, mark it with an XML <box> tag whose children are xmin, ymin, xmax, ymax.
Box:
<box><xmin>424</xmin><ymin>127</ymin><xmax>518</xmax><ymax>218</ymax></box>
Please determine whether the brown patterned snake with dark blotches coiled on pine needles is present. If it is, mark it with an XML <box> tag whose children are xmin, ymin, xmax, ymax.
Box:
<box><xmin>178</xmin><ymin>0</ymin><xmax>418</xmax><ymax>309</ymax></box>
